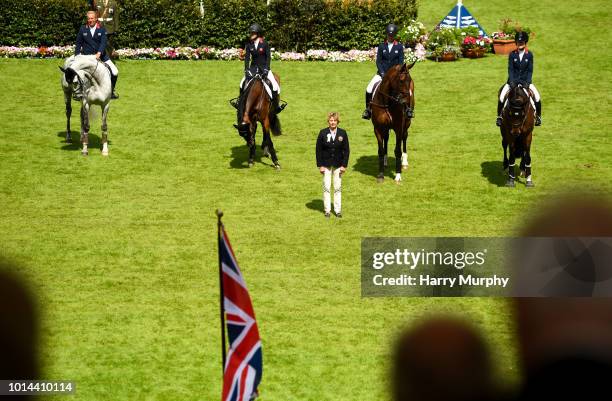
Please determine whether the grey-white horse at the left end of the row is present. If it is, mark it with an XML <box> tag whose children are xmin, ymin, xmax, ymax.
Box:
<box><xmin>59</xmin><ymin>55</ymin><xmax>112</xmax><ymax>156</ymax></box>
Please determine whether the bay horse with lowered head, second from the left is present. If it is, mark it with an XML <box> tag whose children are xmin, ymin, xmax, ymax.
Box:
<box><xmin>237</xmin><ymin>74</ymin><xmax>282</xmax><ymax>170</ymax></box>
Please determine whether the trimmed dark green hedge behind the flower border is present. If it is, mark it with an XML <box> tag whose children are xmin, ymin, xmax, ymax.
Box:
<box><xmin>0</xmin><ymin>0</ymin><xmax>417</xmax><ymax>51</ymax></box>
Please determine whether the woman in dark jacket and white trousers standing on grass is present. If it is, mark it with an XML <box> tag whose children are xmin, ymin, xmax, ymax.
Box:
<box><xmin>316</xmin><ymin>112</ymin><xmax>350</xmax><ymax>218</ymax></box>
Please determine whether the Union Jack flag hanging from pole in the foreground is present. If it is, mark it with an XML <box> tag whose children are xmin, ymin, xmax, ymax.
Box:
<box><xmin>219</xmin><ymin>228</ymin><xmax>263</xmax><ymax>401</ymax></box>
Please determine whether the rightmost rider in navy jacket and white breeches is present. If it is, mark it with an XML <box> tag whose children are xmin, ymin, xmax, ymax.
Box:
<box><xmin>495</xmin><ymin>32</ymin><xmax>542</xmax><ymax>127</ymax></box>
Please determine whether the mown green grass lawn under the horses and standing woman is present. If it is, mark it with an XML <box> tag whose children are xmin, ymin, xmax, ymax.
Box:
<box><xmin>0</xmin><ymin>0</ymin><xmax>612</xmax><ymax>401</ymax></box>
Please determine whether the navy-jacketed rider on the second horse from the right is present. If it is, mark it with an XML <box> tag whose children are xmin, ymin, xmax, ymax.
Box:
<box><xmin>361</xmin><ymin>24</ymin><xmax>412</xmax><ymax>120</ymax></box>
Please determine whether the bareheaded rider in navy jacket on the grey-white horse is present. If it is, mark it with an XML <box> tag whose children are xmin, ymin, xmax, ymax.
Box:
<box><xmin>74</xmin><ymin>11</ymin><xmax>119</xmax><ymax>99</ymax></box>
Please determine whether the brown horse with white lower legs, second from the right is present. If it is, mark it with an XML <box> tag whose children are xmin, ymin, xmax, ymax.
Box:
<box><xmin>370</xmin><ymin>63</ymin><xmax>414</xmax><ymax>183</ymax></box>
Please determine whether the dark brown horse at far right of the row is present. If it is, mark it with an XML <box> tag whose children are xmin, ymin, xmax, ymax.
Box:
<box><xmin>498</xmin><ymin>84</ymin><xmax>535</xmax><ymax>187</ymax></box>
